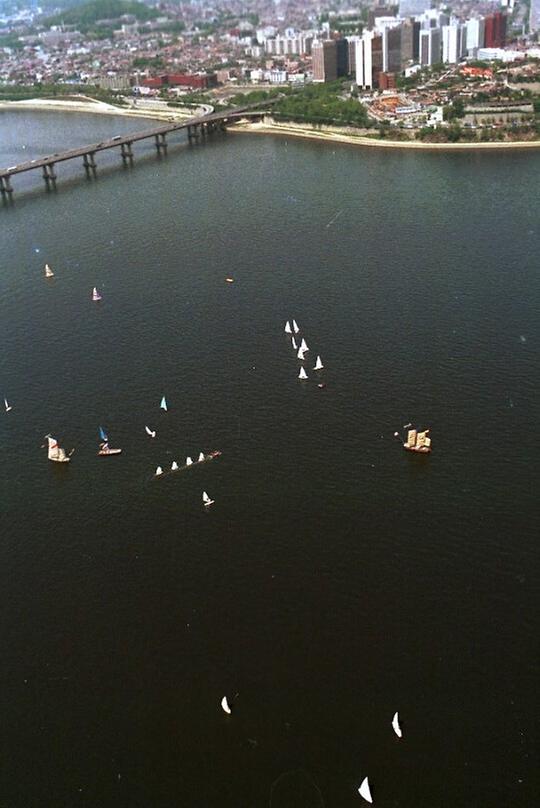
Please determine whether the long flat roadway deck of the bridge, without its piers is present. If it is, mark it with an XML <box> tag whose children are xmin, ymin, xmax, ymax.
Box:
<box><xmin>0</xmin><ymin>99</ymin><xmax>277</xmax><ymax>177</ymax></box>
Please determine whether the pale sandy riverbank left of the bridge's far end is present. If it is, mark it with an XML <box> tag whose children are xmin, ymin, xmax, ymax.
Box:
<box><xmin>0</xmin><ymin>96</ymin><xmax>200</xmax><ymax>121</ymax></box>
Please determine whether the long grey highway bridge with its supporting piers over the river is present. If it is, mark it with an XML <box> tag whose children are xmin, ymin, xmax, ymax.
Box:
<box><xmin>0</xmin><ymin>98</ymin><xmax>278</xmax><ymax>201</ymax></box>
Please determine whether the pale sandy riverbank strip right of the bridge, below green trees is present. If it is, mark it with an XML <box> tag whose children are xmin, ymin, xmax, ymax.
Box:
<box><xmin>229</xmin><ymin>118</ymin><xmax>540</xmax><ymax>151</ymax></box>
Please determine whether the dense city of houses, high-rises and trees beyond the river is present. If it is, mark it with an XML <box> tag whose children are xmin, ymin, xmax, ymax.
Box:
<box><xmin>0</xmin><ymin>0</ymin><xmax>540</xmax><ymax>141</ymax></box>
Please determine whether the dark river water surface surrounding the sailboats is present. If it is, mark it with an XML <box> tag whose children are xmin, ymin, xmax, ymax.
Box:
<box><xmin>0</xmin><ymin>113</ymin><xmax>540</xmax><ymax>808</ymax></box>
